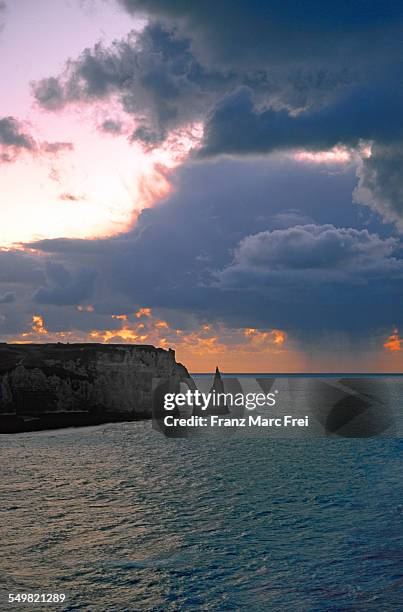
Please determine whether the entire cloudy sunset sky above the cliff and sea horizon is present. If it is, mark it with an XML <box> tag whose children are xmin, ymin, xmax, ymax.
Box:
<box><xmin>0</xmin><ymin>0</ymin><xmax>403</xmax><ymax>372</ymax></box>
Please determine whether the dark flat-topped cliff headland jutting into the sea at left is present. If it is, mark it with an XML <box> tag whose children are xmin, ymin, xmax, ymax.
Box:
<box><xmin>0</xmin><ymin>344</ymin><xmax>189</xmax><ymax>433</ymax></box>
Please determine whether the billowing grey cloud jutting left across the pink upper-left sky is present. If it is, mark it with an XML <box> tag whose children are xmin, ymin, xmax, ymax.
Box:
<box><xmin>33</xmin><ymin>23</ymin><xmax>235</xmax><ymax>142</ymax></box>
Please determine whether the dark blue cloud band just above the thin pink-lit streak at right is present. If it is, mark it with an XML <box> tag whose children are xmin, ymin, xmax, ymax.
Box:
<box><xmin>201</xmin><ymin>86</ymin><xmax>403</xmax><ymax>155</ymax></box>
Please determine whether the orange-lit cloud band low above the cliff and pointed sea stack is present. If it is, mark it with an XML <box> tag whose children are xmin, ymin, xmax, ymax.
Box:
<box><xmin>10</xmin><ymin>305</ymin><xmax>298</xmax><ymax>372</ymax></box>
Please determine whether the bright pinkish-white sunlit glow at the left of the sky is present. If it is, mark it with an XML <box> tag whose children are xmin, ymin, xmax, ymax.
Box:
<box><xmin>0</xmin><ymin>113</ymin><xmax>200</xmax><ymax>246</ymax></box>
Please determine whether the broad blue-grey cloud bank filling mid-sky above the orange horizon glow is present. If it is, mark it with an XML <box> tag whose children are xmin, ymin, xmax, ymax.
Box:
<box><xmin>15</xmin><ymin>159</ymin><xmax>403</xmax><ymax>336</ymax></box>
